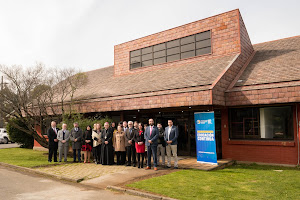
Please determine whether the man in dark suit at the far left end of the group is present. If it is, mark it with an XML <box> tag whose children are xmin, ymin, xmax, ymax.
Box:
<box><xmin>47</xmin><ymin>121</ymin><xmax>59</xmax><ymax>162</ymax></box>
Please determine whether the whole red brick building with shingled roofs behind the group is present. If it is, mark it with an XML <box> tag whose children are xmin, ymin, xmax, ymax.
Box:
<box><xmin>34</xmin><ymin>10</ymin><xmax>300</xmax><ymax>165</ymax></box>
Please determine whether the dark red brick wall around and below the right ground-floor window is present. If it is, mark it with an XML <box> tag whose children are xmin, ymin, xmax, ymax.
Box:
<box><xmin>222</xmin><ymin>105</ymin><xmax>300</xmax><ymax>165</ymax></box>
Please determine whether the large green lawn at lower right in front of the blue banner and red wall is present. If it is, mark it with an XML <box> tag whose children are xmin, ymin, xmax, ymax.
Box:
<box><xmin>127</xmin><ymin>164</ymin><xmax>300</xmax><ymax>199</ymax></box>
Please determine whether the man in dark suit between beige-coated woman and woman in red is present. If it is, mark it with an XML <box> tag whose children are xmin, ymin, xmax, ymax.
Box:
<box><xmin>125</xmin><ymin>121</ymin><xmax>138</xmax><ymax>167</ymax></box>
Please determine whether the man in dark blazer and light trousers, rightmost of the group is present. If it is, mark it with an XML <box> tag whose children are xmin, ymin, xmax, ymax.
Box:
<box><xmin>165</xmin><ymin>120</ymin><xmax>179</xmax><ymax>169</ymax></box>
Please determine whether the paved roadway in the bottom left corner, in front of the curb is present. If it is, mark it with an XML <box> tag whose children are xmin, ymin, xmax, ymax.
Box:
<box><xmin>0</xmin><ymin>167</ymin><xmax>144</xmax><ymax>200</ymax></box>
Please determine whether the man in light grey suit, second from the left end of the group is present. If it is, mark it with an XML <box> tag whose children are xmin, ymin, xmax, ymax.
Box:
<box><xmin>57</xmin><ymin>124</ymin><xmax>70</xmax><ymax>162</ymax></box>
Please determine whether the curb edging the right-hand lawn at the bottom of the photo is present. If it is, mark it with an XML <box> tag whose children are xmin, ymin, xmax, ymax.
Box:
<box><xmin>106</xmin><ymin>185</ymin><xmax>176</xmax><ymax>200</ymax></box>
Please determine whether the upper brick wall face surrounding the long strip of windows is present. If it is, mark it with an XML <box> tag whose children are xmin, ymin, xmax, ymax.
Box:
<box><xmin>114</xmin><ymin>10</ymin><xmax>241</xmax><ymax>76</ymax></box>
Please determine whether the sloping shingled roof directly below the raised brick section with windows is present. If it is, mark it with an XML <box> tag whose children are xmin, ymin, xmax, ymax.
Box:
<box><xmin>74</xmin><ymin>55</ymin><xmax>236</xmax><ymax>99</ymax></box>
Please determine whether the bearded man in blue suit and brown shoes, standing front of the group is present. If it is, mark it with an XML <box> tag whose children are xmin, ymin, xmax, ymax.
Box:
<box><xmin>145</xmin><ymin>119</ymin><xmax>159</xmax><ymax>171</ymax></box>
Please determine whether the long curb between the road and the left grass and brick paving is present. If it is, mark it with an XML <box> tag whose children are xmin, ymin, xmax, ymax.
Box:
<box><xmin>0</xmin><ymin>162</ymin><xmax>82</xmax><ymax>183</ymax></box>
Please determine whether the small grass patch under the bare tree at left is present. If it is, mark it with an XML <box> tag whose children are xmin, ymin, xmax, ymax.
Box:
<box><xmin>0</xmin><ymin>148</ymin><xmax>71</xmax><ymax>168</ymax></box>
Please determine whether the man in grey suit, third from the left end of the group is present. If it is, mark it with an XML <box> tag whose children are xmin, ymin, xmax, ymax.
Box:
<box><xmin>70</xmin><ymin>122</ymin><xmax>83</xmax><ymax>162</ymax></box>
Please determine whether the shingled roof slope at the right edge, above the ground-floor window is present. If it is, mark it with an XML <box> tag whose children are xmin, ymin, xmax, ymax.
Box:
<box><xmin>233</xmin><ymin>36</ymin><xmax>300</xmax><ymax>89</ymax></box>
